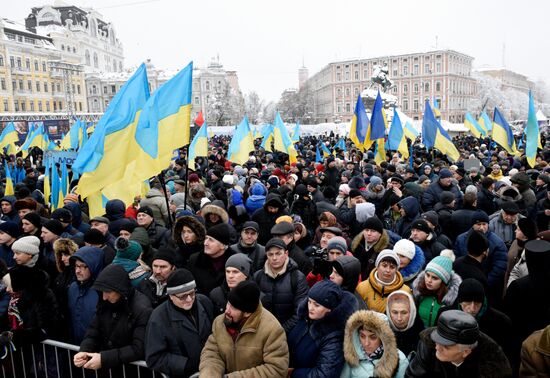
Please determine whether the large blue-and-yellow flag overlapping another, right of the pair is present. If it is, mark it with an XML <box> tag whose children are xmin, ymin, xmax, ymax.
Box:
<box><xmin>130</xmin><ymin>62</ymin><xmax>193</xmax><ymax>183</ymax></box>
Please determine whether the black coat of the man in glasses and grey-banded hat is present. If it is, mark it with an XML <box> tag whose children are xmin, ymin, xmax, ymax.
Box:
<box><xmin>145</xmin><ymin>294</ymin><xmax>212</xmax><ymax>378</ymax></box>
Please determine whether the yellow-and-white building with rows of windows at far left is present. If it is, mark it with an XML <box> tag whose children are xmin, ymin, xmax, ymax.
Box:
<box><xmin>0</xmin><ymin>19</ymin><xmax>88</xmax><ymax>113</ymax></box>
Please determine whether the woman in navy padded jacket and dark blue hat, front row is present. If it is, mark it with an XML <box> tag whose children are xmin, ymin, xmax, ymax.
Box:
<box><xmin>288</xmin><ymin>280</ymin><xmax>357</xmax><ymax>377</ymax></box>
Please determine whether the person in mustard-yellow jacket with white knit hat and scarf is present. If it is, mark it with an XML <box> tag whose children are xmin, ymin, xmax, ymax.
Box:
<box><xmin>357</xmin><ymin>249</ymin><xmax>411</xmax><ymax>313</ymax></box>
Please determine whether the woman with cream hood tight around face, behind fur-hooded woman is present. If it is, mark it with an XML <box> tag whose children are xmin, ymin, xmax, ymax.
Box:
<box><xmin>386</xmin><ymin>290</ymin><xmax>424</xmax><ymax>357</ymax></box>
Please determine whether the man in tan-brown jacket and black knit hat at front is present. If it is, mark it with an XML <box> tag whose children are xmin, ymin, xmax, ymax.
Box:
<box><xmin>199</xmin><ymin>281</ymin><xmax>289</xmax><ymax>378</ymax></box>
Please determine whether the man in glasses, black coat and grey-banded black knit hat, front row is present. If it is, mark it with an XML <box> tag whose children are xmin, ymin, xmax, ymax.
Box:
<box><xmin>145</xmin><ymin>268</ymin><xmax>212</xmax><ymax>377</ymax></box>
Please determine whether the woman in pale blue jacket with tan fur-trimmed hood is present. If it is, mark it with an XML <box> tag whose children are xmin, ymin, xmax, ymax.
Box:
<box><xmin>340</xmin><ymin>310</ymin><xmax>409</xmax><ymax>378</ymax></box>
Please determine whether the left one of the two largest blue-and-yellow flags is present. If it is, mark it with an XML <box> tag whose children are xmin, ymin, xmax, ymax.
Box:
<box><xmin>73</xmin><ymin>64</ymin><xmax>149</xmax><ymax>198</ymax></box>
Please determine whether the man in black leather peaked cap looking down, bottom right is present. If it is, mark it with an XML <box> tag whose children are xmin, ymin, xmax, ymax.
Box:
<box><xmin>405</xmin><ymin>310</ymin><xmax>512</xmax><ymax>378</ymax></box>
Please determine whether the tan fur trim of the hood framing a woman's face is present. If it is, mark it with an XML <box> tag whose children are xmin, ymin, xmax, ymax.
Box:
<box><xmin>344</xmin><ymin>310</ymin><xmax>399</xmax><ymax>377</ymax></box>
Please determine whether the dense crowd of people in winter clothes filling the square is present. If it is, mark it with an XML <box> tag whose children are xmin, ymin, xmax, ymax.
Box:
<box><xmin>0</xmin><ymin>131</ymin><xmax>550</xmax><ymax>378</ymax></box>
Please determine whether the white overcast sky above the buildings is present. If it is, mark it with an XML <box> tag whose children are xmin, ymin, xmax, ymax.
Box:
<box><xmin>4</xmin><ymin>0</ymin><xmax>550</xmax><ymax>101</ymax></box>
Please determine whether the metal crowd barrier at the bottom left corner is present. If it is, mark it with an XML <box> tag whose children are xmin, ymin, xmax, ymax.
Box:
<box><xmin>0</xmin><ymin>339</ymin><xmax>167</xmax><ymax>378</ymax></box>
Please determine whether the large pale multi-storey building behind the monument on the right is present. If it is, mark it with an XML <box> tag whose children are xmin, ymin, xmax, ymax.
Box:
<box><xmin>307</xmin><ymin>50</ymin><xmax>476</xmax><ymax>123</ymax></box>
